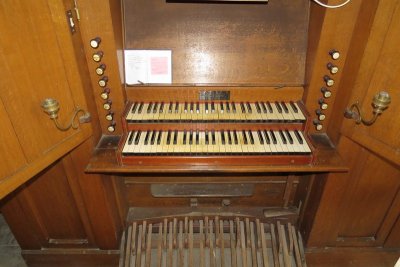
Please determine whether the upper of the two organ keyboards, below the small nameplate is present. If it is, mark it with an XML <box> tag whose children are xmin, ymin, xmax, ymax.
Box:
<box><xmin>125</xmin><ymin>101</ymin><xmax>306</xmax><ymax>123</ymax></box>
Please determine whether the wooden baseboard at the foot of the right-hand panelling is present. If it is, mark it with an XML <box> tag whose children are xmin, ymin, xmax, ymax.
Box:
<box><xmin>306</xmin><ymin>249</ymin><xmax>400</xmax><ymax>267</ymax></box>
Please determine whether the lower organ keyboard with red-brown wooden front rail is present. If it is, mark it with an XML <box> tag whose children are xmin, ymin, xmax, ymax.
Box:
<box><xmin>121</xmin><ymin>129</ymin><xmax>312</xmax><ymax>164</ymax></box>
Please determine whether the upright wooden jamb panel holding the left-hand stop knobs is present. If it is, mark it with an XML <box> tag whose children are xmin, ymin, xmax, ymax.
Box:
<box><xmin>78</xmin><ymin>0</ymin><xmax>125</xmax><ymax>134</ymax></box>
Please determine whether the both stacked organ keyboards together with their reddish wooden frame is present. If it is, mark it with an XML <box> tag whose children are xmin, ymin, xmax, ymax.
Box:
<box><xmin>118</xmin><ymin>100</ymin><xmax>312</xmax><ymax>165</ymax></box>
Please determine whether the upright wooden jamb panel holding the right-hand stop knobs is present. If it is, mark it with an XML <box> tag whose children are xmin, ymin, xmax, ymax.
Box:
<box><xmin>303</xmin><ymin>0</ymin><xmax>362</xmax><ymax>132</ymax></box>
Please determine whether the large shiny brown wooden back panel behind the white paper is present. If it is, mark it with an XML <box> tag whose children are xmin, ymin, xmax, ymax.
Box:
<box><xmin>124</xmin><ymin>0</ymin><xmax>309</xmax><ymax>85</ymax></box>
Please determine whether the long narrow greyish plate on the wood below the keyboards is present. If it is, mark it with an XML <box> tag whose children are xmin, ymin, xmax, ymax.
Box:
<box><xmin>151</xmin><ymin>184</ymin><xmax>254</xmax><ymax>197</ymax></box>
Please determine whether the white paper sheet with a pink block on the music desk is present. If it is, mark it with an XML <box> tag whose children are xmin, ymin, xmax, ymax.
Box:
<box><xmin>124</xmin><ymin>50</ymin><xmax>172</xmax><ymax>84</ymax></box>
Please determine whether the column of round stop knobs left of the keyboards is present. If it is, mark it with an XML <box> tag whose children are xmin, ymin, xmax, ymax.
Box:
<box><xmin>90</xmin><ymin>37</ymin><xmax>116</xmax><ymax>132</ymax></box>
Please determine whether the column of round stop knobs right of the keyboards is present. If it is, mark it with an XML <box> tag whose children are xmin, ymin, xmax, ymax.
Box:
<box><xmin>313</xmin><ymin>50</ymin><xmax>340</xmax><ymax>131</ymax></box>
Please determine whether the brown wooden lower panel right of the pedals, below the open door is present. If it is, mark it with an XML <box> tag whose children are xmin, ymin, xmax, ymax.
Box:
<box><xmin>308</xmin><ymin>137</ymin><xmax>400</xmax><ymax>247</ymax></box>
